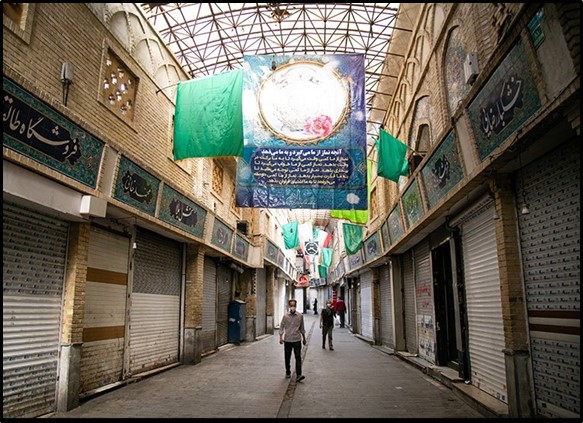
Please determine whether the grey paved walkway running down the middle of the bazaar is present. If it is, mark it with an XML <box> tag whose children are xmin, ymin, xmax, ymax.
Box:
<box><xmin>52</xmin><ymin>312</ymin><xmax>484</xmax><ymax>419</ymax></box>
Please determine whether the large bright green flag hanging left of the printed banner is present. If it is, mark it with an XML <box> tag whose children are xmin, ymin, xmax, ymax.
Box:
<box><xmin>174</xmin><ymin>69</ymin><xmax>243</xmax><ymax>160</ymax></box>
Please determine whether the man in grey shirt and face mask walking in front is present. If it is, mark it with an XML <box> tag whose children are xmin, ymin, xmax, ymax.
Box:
<box><xmin>279</xmin><ymin>299</ymin><xmax>306</xmax><ymax>382</ymax></box>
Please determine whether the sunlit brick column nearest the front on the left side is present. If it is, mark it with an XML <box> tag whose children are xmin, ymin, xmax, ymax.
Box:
<box><xmin>57</xmin><ymin>223</ymin><xmax>91</xmax><ymax>411</ymax></box>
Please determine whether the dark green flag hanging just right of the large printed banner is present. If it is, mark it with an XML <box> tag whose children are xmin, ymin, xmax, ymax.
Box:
<box><xmin>375</xmin><ymin>128</ymin><xmax>409</xmax><ymax>182</ymax></box>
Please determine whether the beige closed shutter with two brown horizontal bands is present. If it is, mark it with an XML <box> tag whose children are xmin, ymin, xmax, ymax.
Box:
<box><xmin>80</xmin><ymin>227</ymin><xmax>130</xmax><ymax>397</ymax></box>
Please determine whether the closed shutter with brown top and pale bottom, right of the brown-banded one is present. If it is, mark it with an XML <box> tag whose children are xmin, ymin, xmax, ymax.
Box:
<box><xmin>129</xmin><ymin>228</ymin><xmax>182</xmax><ymax>375</ymax></box>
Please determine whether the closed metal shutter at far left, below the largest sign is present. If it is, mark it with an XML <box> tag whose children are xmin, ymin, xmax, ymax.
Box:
<box><xmin>2</xmin><ymin>202</ymin><xmax>69</xmax><ymax>418</ymax></box>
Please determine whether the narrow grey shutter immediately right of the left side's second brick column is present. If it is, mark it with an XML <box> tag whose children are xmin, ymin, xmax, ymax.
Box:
<box><xmin>201</xmin><ymin>256</ymin><xmax>217</xmax><ymax>353</ymax></box>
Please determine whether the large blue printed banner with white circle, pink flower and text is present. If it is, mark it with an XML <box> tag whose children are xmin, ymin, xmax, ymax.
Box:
<box><xmin>236</xmin><ymin>54</ymin><xmax>368</xmax><ymax>210</ymax></box>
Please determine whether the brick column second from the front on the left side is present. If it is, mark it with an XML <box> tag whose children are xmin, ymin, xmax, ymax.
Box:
<box><xmin>187</xmin><ymin>244</ymin><xmax>205</xmax><ymax>364</ymax></box>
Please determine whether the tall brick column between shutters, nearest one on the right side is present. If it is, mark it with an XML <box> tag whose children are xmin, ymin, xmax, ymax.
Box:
<box><xmin>490</xmin><ymin>175</ymin><xmax>534</xmax><ymax>417</ymax></box>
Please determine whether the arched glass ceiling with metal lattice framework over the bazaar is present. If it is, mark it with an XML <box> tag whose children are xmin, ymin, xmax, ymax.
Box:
<box><xmin>141</xmin><ymin>3</ymin><xmax>410</xmax><ymax>226</ymax></box>
